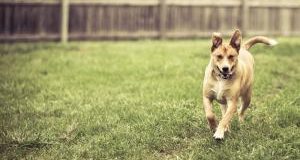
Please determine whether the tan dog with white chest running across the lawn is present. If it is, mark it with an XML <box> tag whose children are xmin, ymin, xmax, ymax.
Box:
<box><xmin>203</xmin><ymin>30</ymin><xmax>277</xmax><ymax>139</ymax></box>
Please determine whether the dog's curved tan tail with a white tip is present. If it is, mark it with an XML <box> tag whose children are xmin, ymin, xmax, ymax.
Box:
<box><xmin>244</xmin><ymin>36</ymin><xmax>278</xmax><ymax>50</ymax></box>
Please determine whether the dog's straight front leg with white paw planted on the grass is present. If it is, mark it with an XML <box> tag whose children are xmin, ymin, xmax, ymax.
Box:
<box><xmin>214</xmin><ymin>98</ymin><xmax>238</xmax><ymax>139</ymax></box>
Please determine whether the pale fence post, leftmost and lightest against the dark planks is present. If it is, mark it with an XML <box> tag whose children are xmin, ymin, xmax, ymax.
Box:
<box><xmin>60</xmin><ymin>0</ymin><xmax>70</xmax><ymax>43</ymax></box>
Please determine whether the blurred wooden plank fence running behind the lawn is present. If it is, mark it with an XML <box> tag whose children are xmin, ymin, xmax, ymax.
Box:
<box><xmin>0</xmin><ymin>0</ymin><xmax>300</xmax><ymax>42</ymax></box>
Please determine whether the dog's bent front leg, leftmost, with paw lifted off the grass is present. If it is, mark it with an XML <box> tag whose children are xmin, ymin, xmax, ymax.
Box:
<box><xmin>203</xmin><ymin>96</ymin><xmax>217</xmax><ymax>131</ymax></box>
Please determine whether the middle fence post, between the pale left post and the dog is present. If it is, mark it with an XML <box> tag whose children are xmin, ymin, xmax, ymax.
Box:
<box><xmin>159</xmin><ymin>0</ymin><xmax>167</xmax><ymax>39</ymax></box>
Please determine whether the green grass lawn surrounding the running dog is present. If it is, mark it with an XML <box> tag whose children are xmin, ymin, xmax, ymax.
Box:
<box><xmin>0</xmin><ymin>38</ymin><xmax>300</xmax><ymax>160</ymax></box>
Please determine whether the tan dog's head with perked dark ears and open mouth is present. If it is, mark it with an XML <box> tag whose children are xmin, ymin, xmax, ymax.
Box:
<box><xmin>211</xmin><ymin>30</ymin><xmax>242</xmax><ymax>79</ymax></box>
